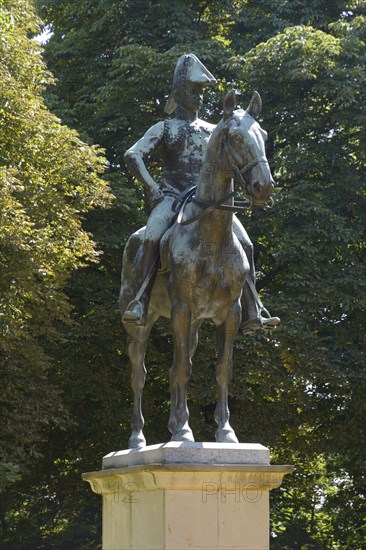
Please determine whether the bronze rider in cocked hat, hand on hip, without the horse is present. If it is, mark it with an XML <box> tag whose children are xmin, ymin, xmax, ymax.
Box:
<box><xmin>123</xmin><ymin>54</ymin><xmax>280</xmax><ymax>332</ymax></box>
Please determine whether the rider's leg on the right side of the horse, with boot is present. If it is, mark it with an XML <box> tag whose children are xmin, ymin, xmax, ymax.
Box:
<box><xmin>233</xmin><ymin>216</ymin><xmax>281</xmax><ymax>333</ymax></box>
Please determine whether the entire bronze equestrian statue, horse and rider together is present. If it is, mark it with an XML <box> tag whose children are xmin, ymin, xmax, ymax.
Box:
<box><xmin>120</xmin><ymin>54</ymin><xmax>279</xmax><ymax>448</ymax></box>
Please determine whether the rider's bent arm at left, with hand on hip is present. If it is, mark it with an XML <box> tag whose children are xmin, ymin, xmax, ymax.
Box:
<box><xmin>125</xmin><ymin>122</ymin><xmax>164</xmax><ymax>203</ymax></box>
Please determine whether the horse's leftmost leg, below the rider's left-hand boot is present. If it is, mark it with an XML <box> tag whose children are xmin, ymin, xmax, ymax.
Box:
<box><xmin>126</xmin><ymin>323</ymin><xmax>152</xmax><ymax>449</ymax></box>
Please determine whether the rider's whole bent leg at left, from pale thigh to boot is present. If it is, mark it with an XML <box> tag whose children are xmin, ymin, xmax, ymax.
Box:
<box><xmin>122</xmin><ymin>197</ymin><xmax>175</xmax><ymax>325</ymax></box>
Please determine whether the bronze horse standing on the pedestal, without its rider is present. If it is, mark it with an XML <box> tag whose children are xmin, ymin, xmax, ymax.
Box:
<box><xmin>119</xmin><ymin>90</ymin><xmax>274</xmax><ymax>448</ymax></box>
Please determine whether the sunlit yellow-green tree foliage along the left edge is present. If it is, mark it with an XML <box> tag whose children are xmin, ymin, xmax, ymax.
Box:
<box><xmin>0</xmin><ymin>0</ymin><xmax>108</xmax><ymax>500</ymax></box>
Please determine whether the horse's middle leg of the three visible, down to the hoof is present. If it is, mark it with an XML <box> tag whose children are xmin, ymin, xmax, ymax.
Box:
<box><xmin>168</xmin><ymin>300</ymin><xmax>194</xmax><ymax>441</ymax></box>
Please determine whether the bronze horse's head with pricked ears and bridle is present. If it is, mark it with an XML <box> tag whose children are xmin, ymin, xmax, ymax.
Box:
<box><xmin>222</xmin><ymin>90</ymin><xmax>274</xmax><ymax>206</ymax></box>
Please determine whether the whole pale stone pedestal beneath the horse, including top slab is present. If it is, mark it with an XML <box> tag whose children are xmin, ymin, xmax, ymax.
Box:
<box><xmin>83</xmin><ymin>442</ymin><xmax>293</xmax><ymax>550</ymax></box>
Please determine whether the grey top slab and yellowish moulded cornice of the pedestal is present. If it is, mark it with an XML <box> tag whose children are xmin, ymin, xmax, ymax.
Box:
<box><xmin>83</xmin><ymin>442</ymin><xmax>293</xmax><ymax>494</ymax></box>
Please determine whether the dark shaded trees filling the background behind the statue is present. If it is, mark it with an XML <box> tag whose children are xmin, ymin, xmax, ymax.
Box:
<box><xmin>1</xmin><ymin>0</ymin><xmax>366</xmax><ymax>550</ymax></box>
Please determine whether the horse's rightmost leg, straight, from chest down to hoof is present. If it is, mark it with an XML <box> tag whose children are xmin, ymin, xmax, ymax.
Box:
<box><xmin>215</xmin><ymin>300</ymin><xmax>241</xmax><ymax>443</ymax></box>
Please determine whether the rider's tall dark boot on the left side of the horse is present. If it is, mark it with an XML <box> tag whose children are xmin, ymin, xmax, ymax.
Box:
<box><xmin>122</xmin><ymin>241</ymin><xmax>158</xmax><ymax>326</ymax></box>
